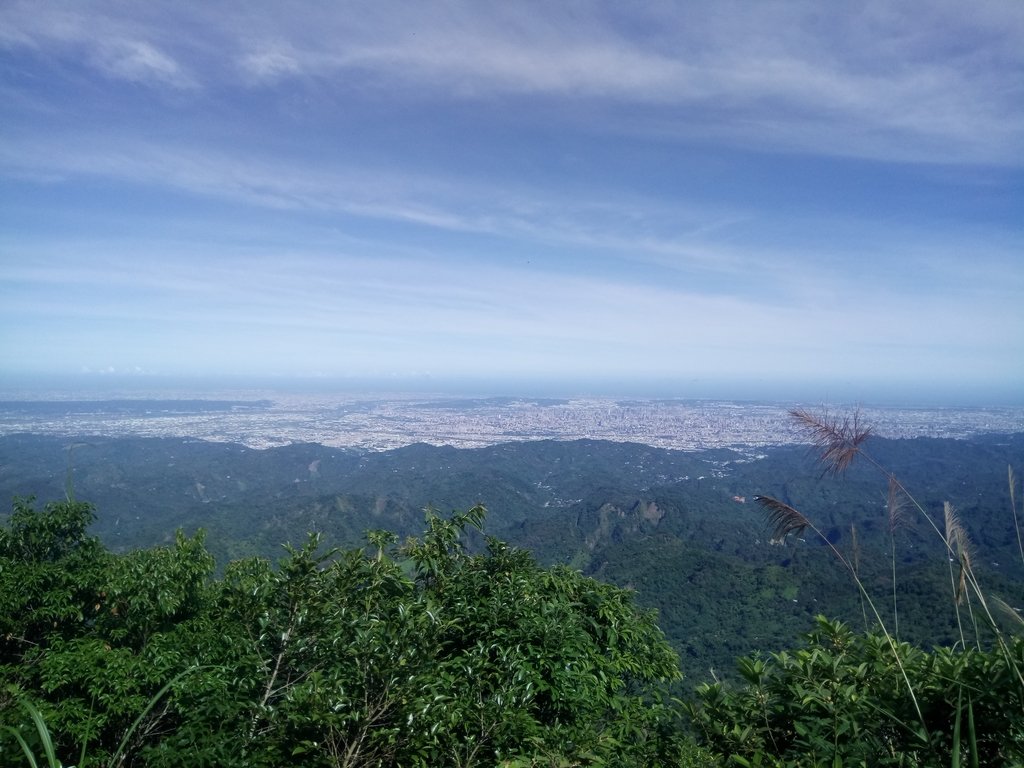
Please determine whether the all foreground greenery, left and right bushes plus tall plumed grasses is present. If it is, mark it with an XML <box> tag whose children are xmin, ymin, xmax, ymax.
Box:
<box><xmin>0</xmin><ymin>415</ymin><xmax>1024</xmax><ymax>767</ymax></box>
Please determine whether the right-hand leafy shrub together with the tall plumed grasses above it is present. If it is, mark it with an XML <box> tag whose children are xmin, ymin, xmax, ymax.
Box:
<box><xmin>690</xmin><ymin>411</ymin><xmax>1024</xmax><ymax>766</ymax></box>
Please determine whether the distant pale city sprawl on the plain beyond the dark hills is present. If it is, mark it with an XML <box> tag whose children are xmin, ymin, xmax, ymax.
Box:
<box><xmin>0</xmin><ymin>391</ymin><xmax>1024</xmax><ymax>451</ymax></box>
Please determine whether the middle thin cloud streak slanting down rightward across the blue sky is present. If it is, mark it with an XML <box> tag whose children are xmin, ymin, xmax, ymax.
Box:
<box><xmin>0</xmin><ymin>129</ymin><xmax>1020</xmax><ymax>309</ymax></box>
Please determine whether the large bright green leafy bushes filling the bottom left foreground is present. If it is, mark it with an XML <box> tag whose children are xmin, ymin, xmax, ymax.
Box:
<box><xmin>0</xmin><ymin>502</ymin><xmax>712</xmax><ymax>766</ymax></box>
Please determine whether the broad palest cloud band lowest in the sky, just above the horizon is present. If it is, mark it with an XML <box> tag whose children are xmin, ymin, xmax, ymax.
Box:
<box><xmin>0</xmin><ymin>227</ymin><xmax>1014</xmax><ymax>382</ymax></box>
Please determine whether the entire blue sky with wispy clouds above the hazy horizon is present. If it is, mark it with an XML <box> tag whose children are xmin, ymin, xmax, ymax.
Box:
<box><xmin>0</xmin><ymin>0</ymin><xmax>1024</xmax><ymax>399</ymax></box>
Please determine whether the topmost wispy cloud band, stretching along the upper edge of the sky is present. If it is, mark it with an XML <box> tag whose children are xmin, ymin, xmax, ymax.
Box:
<box><xmin>8</xmin><ymin>0</ymin><xmax>1024</xmax><ymax>165</ymax></box>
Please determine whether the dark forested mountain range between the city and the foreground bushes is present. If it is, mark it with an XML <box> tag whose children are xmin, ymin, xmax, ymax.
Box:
<box><xmin>0</xmin><ymin>434</ymin><xmax>1024</xmax><ymax>684</ymax></box>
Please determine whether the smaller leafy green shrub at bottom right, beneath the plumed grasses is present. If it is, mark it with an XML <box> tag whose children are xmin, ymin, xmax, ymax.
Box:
<box><xmin>690</xmin><ymin>616</ymin><xmax>1024</xmax><ymax>766</ymax></box>
